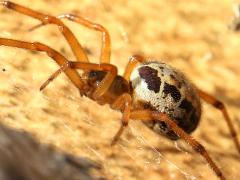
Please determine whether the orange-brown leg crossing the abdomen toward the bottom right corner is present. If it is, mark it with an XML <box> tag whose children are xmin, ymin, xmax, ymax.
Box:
<box><xmin>130</xmin><ymin>110</ymin><xmax>226</xmax><ymax>180</ymax></box>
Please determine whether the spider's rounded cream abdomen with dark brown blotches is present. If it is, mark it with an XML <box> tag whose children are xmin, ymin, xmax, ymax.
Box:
<box><xmin>130</xmin><ymin>62</ymin><xmax>201</xmax><ymax>140</ymax></box>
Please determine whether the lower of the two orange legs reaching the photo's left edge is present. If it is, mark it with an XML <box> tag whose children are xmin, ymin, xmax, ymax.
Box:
<box><xmin>0</xmin><ymin>38</ymin><xmax>83</xmax><ymax>91</ymax></box>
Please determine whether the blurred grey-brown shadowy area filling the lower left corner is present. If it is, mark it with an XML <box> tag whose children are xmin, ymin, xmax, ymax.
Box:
<box><xmin>0</xmin><ymin>123</ymin><xmax>105</xmax><ymax>180</ymax></box>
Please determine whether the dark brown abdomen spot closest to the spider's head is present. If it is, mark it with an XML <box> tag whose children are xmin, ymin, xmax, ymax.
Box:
<box><xmin>138</xmin><ymin>66</ymin><xmax>161</xmax><ymax>93</ymax></box>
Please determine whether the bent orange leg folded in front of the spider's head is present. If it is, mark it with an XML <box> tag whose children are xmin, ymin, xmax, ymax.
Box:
<box><xmin>41</xmin><ymin>61</ymin><xmax>117</xmax><ymax>99</ymax></box>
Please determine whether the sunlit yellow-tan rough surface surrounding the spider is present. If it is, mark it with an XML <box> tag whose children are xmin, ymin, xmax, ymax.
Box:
<box><xmin>0</xmin><ymin>0</ymin><xmax>240</xmax><ymax>180</ymax></box>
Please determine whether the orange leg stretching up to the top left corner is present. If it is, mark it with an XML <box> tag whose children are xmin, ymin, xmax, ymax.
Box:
<box><xmin>0</xmin><ymin>1</ymin><xmax>88</xmax><ymax>62</ymax></box>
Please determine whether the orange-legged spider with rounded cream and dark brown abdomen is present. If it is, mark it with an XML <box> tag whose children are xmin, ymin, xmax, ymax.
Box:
<box><xmin>0</xmin><ymin>1</ymin><xmax>240</xmax><ymax>180</ymax></box>
